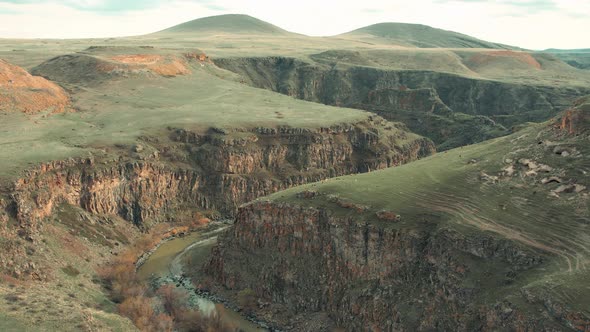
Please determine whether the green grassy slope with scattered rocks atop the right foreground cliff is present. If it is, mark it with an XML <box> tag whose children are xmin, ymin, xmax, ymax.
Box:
<box><xmin>265</xmin><ymin>99</ymin><xmax>590</xmax><ymax>316</ymax></box>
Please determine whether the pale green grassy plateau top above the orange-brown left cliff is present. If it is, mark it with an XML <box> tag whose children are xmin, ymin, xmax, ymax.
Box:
<box><xmin>0</xmin><ymin>48</ymin><xmax>369</xmax><ymax>182</ymax></box>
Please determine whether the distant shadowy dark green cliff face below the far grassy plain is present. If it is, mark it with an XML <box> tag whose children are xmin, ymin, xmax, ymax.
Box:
<box><xmin>215</xmin><ymin>57</ymin><xmax>588</xmax><ymax>149</ymax></box>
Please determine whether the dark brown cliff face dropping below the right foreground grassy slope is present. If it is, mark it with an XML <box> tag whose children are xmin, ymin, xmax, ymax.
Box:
<box><xmin>205</xmin><ymin>202</ymin><xmax>572</xmax><ymax>331</ymax></box>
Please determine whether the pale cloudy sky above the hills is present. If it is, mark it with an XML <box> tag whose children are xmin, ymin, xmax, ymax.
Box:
<box><xmin>0</xmin><ymin>0</ymin><xmax>590</xmax><ymax>50</ymax></box>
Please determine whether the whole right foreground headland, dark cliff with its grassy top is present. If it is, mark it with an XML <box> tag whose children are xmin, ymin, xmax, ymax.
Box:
<box><xmin>203</xmin><ymin>99</ymin><xmax>590</xmax><ymax>331</ymax></box>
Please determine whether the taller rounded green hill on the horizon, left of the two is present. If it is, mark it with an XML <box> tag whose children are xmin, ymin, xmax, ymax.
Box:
<box><xmin>157</xmin><ymin>14</ymin><xmax>291</xmax><ymax>35</ymax></box>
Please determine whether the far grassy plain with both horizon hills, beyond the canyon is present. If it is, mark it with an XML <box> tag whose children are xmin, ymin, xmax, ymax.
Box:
<box><xmin>0</xmin><ymin>15</ymin><xmax>590</xmax><ymax>86</ymax></box>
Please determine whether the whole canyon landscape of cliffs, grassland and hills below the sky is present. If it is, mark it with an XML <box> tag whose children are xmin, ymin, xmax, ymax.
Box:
<box><xmin>0</xmin><ymin>15</ymin><xmax>590</xmax><ymax>332</ymax></box>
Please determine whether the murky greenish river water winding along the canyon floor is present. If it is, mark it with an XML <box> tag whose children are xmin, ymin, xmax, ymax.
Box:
<box><xmin>137</xmin><ymin>224</ymin><xmax>266</xmax><ymax>332</ymax></box>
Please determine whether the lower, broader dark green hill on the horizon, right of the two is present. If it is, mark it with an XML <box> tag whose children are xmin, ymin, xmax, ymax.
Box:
<box><xmin>340</xmin><ymin>23</ymin><xmax>517</xmax><ymax>49</ymax></box>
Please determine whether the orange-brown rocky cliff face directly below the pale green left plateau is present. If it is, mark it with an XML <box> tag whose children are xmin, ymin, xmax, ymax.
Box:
<box><xmin>5</xmin><ymin>117</ymin><xmax>434</xmax><ymax>237</ymax></box>
